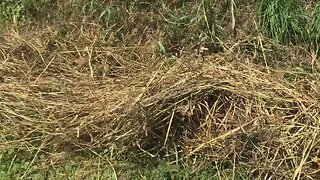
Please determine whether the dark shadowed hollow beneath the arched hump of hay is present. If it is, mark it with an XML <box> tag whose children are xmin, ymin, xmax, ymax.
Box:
<box><xmin>139</xmin><ymin>90</ymin><xmax>232</xmax><ymax>154</ymax></box>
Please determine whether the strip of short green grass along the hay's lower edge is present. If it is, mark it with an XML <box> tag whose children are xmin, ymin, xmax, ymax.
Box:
<box><xmin>0</xmin><ymin>148</ymin><xmax>248</xmax><ymax>180</ymax></box>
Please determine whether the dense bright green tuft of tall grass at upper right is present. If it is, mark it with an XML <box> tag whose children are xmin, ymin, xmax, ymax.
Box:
<box><xmin>258</xmin><ymin>0</ymin><xmax>307</xmax><ymax>44</ymax></box>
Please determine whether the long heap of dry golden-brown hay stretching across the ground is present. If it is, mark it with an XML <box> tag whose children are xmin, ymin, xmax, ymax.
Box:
<box><xmin>0</xmin><ymin>25</ymin><xmax>320</xmax><ymax>178</ymax></box>
